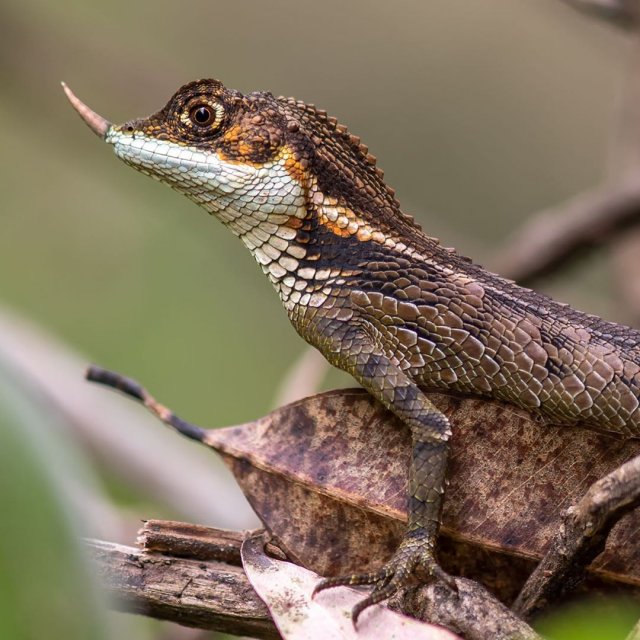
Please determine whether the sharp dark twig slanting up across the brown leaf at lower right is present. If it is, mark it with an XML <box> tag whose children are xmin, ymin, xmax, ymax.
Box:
<box><xmin>513</xmin><ymin>456</ymin><xmax>640</xmax><ymax>618</ymax></box>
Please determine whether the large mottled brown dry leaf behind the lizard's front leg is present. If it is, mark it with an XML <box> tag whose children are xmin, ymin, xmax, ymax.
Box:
<box><xmin>201</xmin><ymin>390</ymin><xmax>640</xmax><ymax>601</ymax></box>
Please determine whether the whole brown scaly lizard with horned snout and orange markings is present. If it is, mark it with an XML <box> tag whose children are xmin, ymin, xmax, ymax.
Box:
<box><xmin>63</xmin><ymin>79</ymin><xmax>640</xmax><ymax>623</ymax></box>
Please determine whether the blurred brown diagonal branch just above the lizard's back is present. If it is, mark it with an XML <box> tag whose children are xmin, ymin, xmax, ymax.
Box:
<box><xmin>491</xmin><ymin>172</ymin><xmax>640</xmax><ymax>284</ymax></box>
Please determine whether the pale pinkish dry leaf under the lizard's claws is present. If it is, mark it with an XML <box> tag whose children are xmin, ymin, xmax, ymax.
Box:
<box><xmin>242</xmin><ymin>536</ymin><xmax>459</xmax><ymax>640</ymax></box>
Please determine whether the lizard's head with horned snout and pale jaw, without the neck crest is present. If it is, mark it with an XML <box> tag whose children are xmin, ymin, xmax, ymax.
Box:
<box><xmin>65</xmin><ymin>80</ymin><xmax>304</xmax><ymax>235</ymax></box>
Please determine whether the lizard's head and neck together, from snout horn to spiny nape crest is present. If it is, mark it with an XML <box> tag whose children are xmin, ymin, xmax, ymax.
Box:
<box><xmin>65</xmin><ymin>80</ymin><xmax>422</xmax><ymax>292</ymax></box>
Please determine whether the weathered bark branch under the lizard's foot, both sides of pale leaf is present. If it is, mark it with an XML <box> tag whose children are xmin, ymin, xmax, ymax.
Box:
<box><xmin>92</xmin><ymin>520</ymin><xmax>539</xmax><ymax>640</ymax></box>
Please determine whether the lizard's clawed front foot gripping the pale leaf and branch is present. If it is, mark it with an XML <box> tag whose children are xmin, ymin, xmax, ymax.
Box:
<box><xmin>312</xmin><ymin>536</ymin><xmax>457</xmax><ymax>626</ymax></box>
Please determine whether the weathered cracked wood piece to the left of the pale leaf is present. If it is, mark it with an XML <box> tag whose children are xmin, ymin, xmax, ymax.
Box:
<box><xmin>87</xmin><ymin>521</ymin><xmax>280</xmax><ymax>640</ymax></box>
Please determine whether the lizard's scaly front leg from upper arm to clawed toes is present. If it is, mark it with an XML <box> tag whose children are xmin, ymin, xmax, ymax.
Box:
<box><xmin>314</xmin><ymin>334</ymin><xmax>451</xmax><ymax>624</ymax></box>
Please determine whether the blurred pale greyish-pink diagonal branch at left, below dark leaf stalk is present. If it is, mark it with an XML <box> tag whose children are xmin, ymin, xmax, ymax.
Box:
<box><xmin>0</xmin><ymin>309</ymin><xmax>256</xmax><ymax>539</ymax></box>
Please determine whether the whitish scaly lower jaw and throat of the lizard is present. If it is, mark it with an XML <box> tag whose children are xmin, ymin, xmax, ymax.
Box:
<box><xmin>106</xmin><ymin>127</ymin><xmax>324</xmax><ymax>307</ymax></box>
